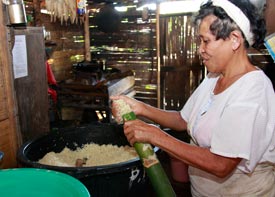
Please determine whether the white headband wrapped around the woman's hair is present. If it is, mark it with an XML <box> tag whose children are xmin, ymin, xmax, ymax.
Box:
<box><xmin>212</xmin><ymin>0</ymin><xmax>254</xmax><ymax>46</ymax></box>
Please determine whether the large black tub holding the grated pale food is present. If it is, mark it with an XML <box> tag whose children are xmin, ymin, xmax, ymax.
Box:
<box><xmin>18</xmin><ymin>123</ymin><xmax>157</xmax><ymax>197</ymax></box>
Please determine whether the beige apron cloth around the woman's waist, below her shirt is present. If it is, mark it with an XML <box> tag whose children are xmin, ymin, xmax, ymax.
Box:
<box><xmin>189</xmin><ymin>163</ymin><xmax>275</xmax><ymax>197</ymax></box>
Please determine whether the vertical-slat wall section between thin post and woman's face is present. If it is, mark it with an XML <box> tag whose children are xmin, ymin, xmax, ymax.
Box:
<box><xmin>160</xmin><ymin>14</ymin><xmax>204</xmax><ymax>110</ymax></box>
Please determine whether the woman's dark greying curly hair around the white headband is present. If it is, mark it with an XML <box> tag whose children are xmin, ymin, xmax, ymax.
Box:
<box><xmin>195</xmin><ymin>0</ymin><xmax>266</xmax><ymax>48</ymax></box>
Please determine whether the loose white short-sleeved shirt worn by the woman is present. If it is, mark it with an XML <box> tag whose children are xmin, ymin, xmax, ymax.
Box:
<box><xmin>181</xmin><ymin>70</ymin><xmax>275</xmax><ymax>173</ymax></box>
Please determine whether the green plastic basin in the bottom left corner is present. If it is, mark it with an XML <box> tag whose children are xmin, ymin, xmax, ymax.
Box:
<box><xmin>0</xmin><ymin>168</ymin><xmax>90</xmax><ymax>197</ymax></box>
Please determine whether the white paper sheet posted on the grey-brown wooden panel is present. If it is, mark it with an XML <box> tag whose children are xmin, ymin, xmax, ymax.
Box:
<box><xmin>12</xmin><ymin>35</ymin><xmax>28</xmax><ymax>79</ymax></box>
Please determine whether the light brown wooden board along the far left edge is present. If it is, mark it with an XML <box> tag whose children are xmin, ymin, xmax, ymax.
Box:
<box><xmin>0</xmin><ymin>1</ymin><xmax>21</xmax><ymax>168</ymax></box>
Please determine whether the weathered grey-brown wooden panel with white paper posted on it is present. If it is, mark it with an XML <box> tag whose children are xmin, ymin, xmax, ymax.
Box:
<box><xmin>14</xmin><ymin>27</ymin><xmax>49</xmax><ymax>142</ymax></box>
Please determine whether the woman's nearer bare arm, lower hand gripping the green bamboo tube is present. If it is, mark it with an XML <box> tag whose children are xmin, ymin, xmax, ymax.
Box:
<box><xmin>124</xmin><ymin>120</ymin><xmax>241</xmax><ymax>177</ymax></box>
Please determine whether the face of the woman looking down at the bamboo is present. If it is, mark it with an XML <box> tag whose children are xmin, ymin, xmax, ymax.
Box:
<box><xmin>199</xmin><ymin>15</ymin><xmax>232</xmax><ymax>73</ymax></box>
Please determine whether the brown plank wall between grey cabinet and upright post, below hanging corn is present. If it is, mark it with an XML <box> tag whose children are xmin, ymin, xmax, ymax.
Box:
<box><xmin>24</xmin><ymin>0</ymin><xmax>85</xmax><ymax>82</ymax></box>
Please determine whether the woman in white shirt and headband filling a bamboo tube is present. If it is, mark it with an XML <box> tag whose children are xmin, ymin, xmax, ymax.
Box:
<box><xmin>111</xmin><ymin>0</ymin><xmax>275</xmax><ymax>197</ymax></box>
